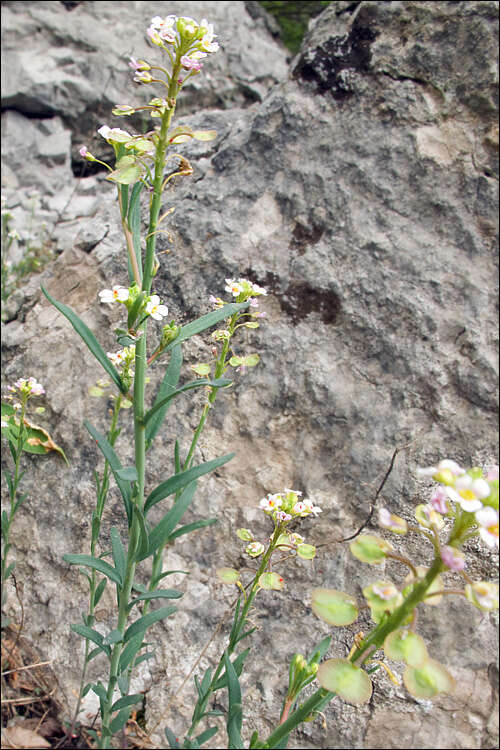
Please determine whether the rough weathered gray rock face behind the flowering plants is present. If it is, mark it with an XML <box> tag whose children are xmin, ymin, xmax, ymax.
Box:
<box><xmin>2</xmin><ymin>0</ymin><xmax>498</xmax><ymax>748</ymax></box>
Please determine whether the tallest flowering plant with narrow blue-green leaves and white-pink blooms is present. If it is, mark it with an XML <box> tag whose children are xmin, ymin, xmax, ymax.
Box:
<box><xmin>36</xmin><ymin>16</ymin><xmax>266</xmax><ymax>748</ymax></box>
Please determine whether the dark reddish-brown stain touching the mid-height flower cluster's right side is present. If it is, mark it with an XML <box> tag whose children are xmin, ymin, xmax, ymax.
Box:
<box><xmin>244</xmin><ymin>269</ymin><xmax>342</xmax><ymax>325</ymax></box>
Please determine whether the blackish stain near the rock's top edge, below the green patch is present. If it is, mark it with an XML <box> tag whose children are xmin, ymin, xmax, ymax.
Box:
<box><xmin>292</xmin><ymin>7</ymin><xmax>377</xmax><ymax>101</ymax></box>
